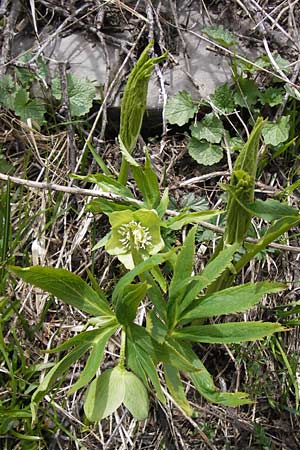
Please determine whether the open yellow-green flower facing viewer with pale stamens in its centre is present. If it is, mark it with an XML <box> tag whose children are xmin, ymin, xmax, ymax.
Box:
<box><xmin>105</xmin><ymin>209</ymin><xmax>165</xmax><ymax>270</ymax></box>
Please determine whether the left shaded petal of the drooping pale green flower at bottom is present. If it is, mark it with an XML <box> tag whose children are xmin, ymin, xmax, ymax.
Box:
<box><xmin>84</xmin><ymin>366</ymin><xmax>126</xmax><ymax>422</ymax></box>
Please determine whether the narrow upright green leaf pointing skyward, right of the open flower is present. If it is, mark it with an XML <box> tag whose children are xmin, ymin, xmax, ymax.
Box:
<box><xmin>167</xmin><ymin>227</ymin><xmax>197</xmax><ymax>328</ymax></box>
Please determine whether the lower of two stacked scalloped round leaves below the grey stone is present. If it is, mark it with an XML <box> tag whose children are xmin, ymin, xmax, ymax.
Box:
<box><xmin>187</xmin><ymin>137</ymin><xmax>223</xmax><ymax>166</ymax></box>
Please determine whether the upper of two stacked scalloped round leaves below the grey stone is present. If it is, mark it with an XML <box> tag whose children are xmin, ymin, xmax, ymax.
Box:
<box><xmin>190</xmin><ymin>113</ymin><xmax>225</xmax><ymax>144</ymax></box>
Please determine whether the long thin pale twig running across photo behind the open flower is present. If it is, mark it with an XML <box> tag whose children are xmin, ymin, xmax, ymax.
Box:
<box><xmin>0</xmin><ymin>172</ymin><xmax>300</xmax><ymax>253</ymax></box>
